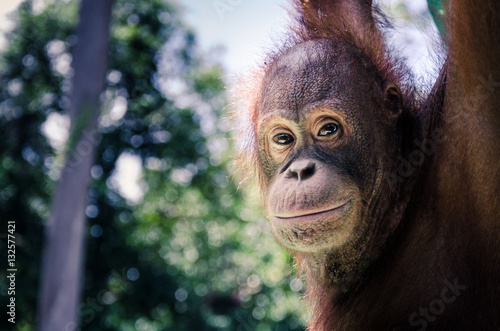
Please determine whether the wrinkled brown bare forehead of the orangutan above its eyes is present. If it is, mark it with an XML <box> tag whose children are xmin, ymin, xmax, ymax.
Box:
<box><xmin>258</xmin><ymin>40</ymin><xmax>372</xmax><ymax>121</ymax></box>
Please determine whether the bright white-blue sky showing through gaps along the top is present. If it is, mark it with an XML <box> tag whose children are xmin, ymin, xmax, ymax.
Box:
<box><xmin>0</xmin><ymin>0</ymin><xmax>438</xmax><ymax>75</ymax></box>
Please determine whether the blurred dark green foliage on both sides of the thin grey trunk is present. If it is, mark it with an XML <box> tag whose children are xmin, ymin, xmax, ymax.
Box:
<box><xmin>0</xmin><ymin>0</ymin><xmax>304</xmax><ymax>330</ymax></box>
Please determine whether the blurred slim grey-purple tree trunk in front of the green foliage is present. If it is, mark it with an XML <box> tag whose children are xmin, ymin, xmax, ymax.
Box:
<box><xmin>38</xmin><ymin>0</ymin><xmax>113</xmax><ymax>331</ymax></box>
